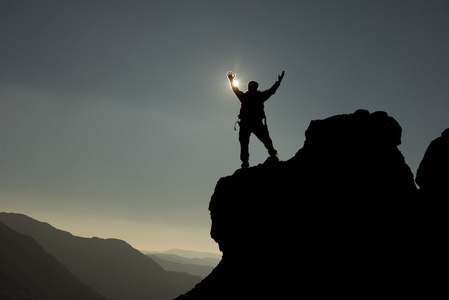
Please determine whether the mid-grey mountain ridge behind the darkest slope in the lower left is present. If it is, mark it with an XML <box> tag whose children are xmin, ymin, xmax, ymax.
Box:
<box><xmin>0</xmin><ymin>213</ymin><xmax>201</xmax><ymax>300</ymax></box>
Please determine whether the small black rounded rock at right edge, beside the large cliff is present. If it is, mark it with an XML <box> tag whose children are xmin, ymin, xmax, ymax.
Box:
<box><xmin>416</xmin><ymin>128</ymin><xmax>449</xmax><ymax>196</ymax></box>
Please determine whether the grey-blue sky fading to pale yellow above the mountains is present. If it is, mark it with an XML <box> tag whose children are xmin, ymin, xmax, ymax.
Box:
<box><xmin>0</xmin><ymin>0</ymin><xmax>449</xmax><ymax>252</ymax></box>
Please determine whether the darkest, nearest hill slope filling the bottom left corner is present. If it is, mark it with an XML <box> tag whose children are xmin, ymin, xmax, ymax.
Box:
<box><xmin>0</xmin><ymin>222</ymin><xmax>105</xmax><ymax>300</ymax></box>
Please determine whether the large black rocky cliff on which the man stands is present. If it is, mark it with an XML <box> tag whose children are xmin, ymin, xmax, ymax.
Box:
<box><xmin>177</xmin><ymin>110</ymin><xmax>447</xmax><ymax>299</ymax></box>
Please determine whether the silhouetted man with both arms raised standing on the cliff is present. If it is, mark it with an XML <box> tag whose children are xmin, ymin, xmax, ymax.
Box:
<box><xmin>227</xmin><ymin>71</ymin><xmax>285</xmax><ymax>168</ymax></box>
